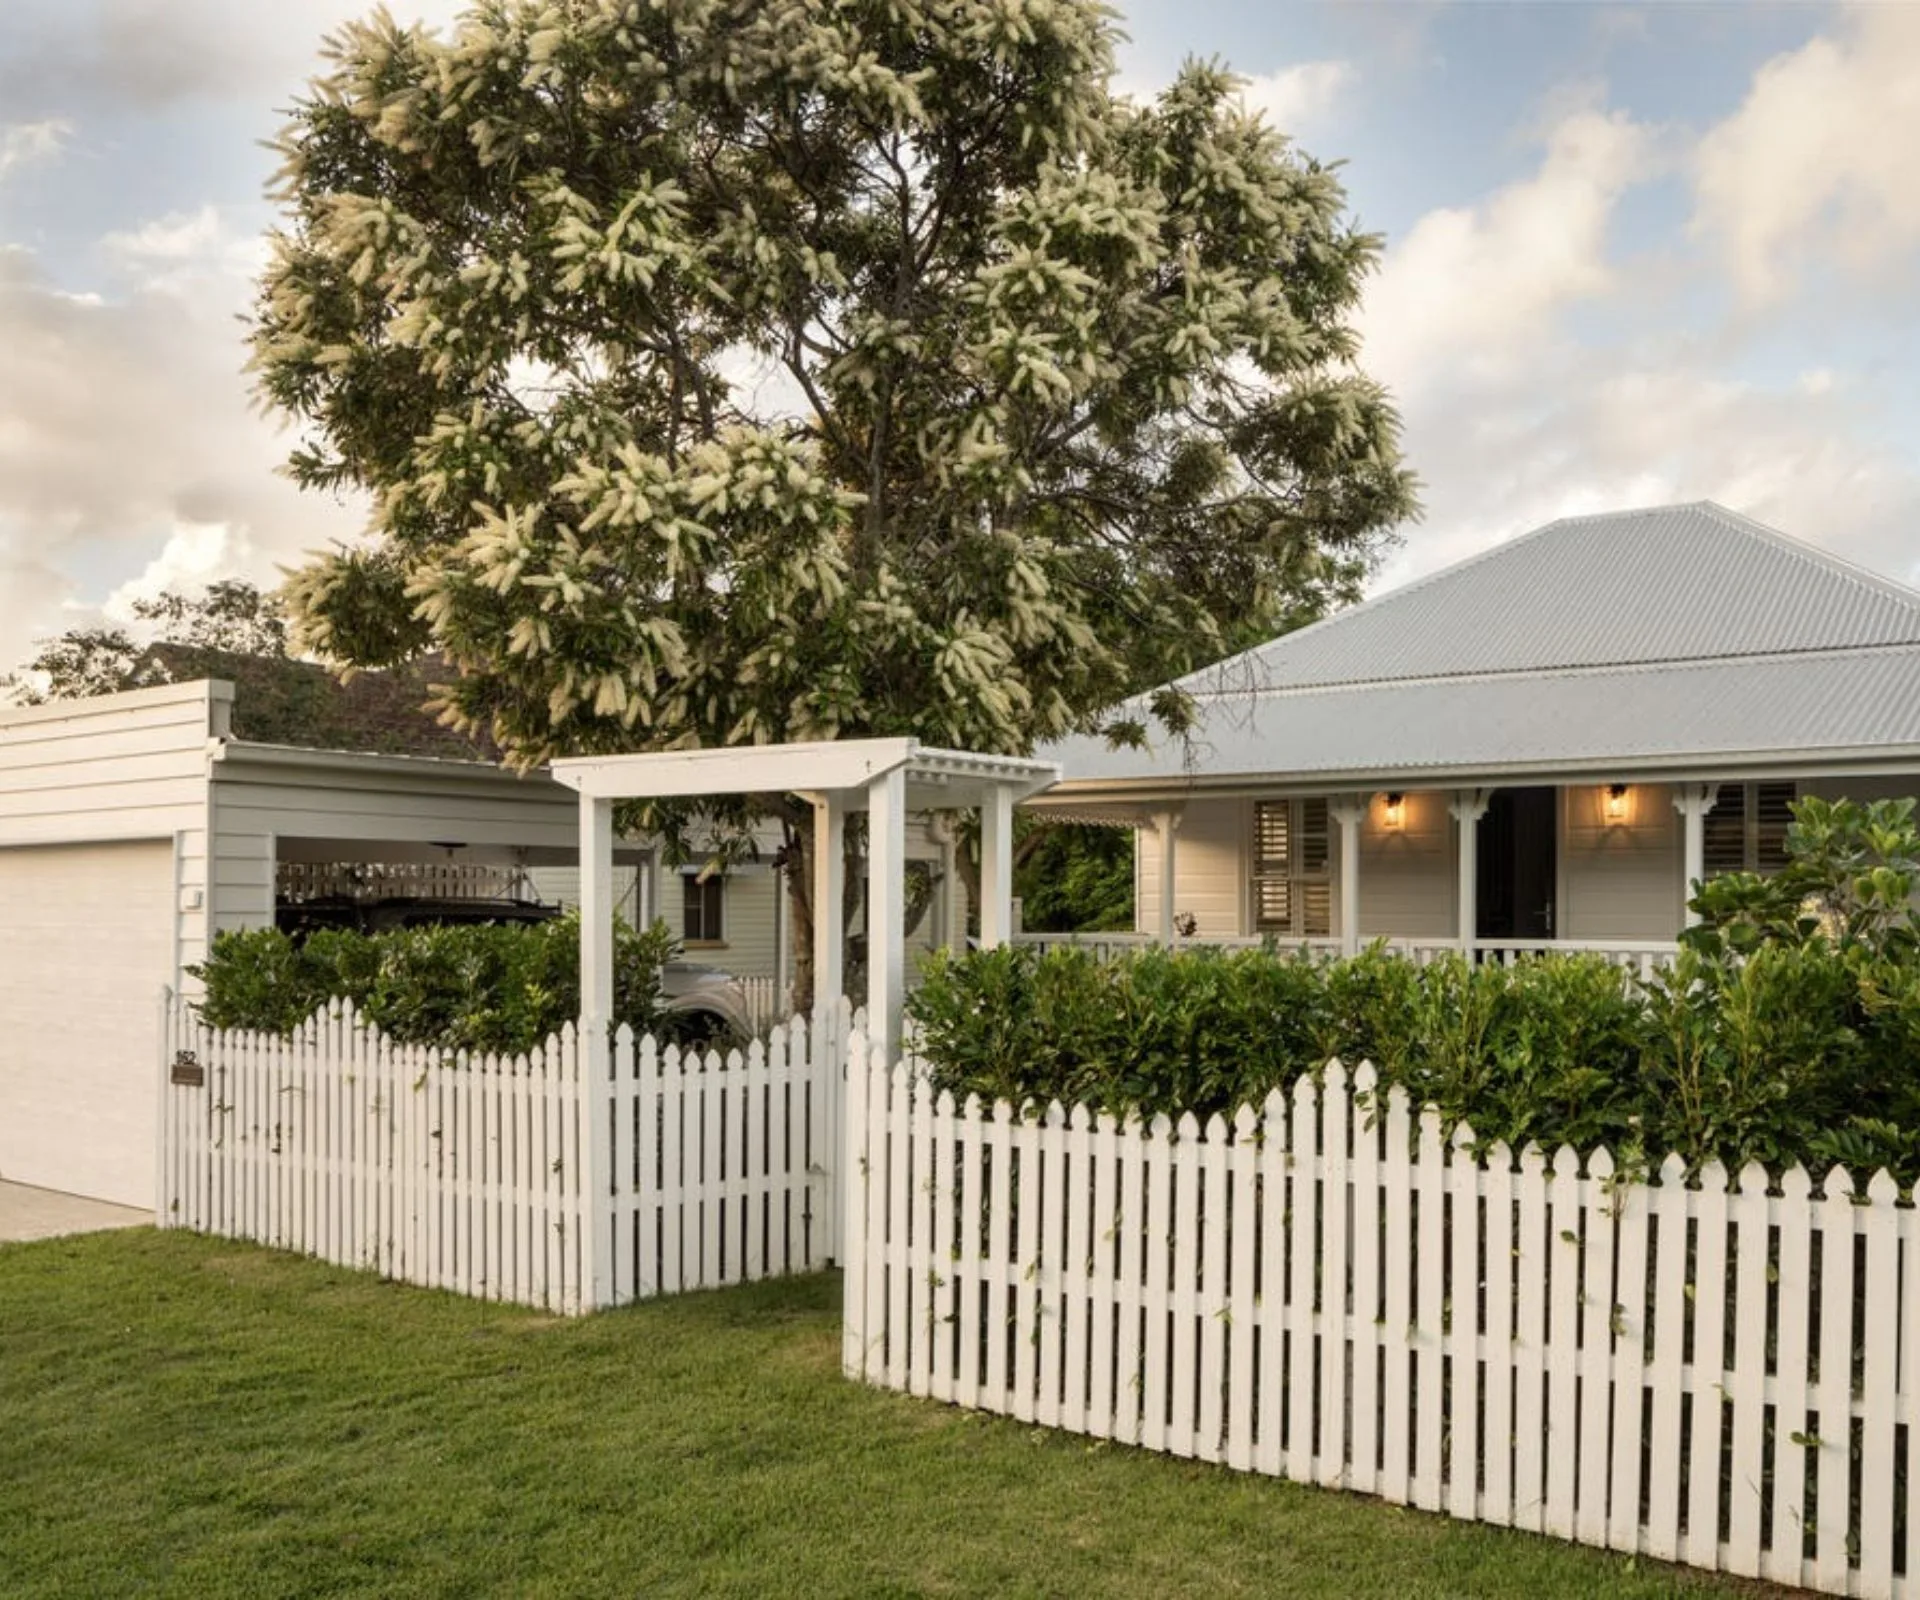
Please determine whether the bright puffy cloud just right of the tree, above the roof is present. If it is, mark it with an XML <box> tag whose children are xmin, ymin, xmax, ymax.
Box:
<box><xmin>1359</xmin><ymin>108</ymin><xmax>1659</xmax><ymax>400</ymax></box>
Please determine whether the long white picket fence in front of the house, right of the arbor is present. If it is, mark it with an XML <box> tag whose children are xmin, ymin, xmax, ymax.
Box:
<box><xmin>845</xmin><ymin>1039</ymin><xmax>1920</xmax><ymax>1596</ymax></box>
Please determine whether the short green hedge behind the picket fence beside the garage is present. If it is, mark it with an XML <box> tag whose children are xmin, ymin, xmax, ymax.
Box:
<box><xmin>190</xmin><ymin>914</ymin><xmax>680</xmax><ymax>1053</ymax></box>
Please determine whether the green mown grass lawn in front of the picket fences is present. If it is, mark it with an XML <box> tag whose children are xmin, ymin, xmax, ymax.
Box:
<box><xmin>0</xmin><ymin>1229</ymin><xmax>1778</xmax><ymax>1600</ymax></box>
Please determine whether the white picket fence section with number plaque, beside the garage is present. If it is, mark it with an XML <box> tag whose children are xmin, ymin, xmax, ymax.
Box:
<box><xmin>157</xmin><ymin>997</ymin><xmax>849</xmax><ymax>1312</ymax></box>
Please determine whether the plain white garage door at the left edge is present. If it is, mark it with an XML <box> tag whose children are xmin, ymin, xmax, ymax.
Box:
<box><xmin>0</xmin><ymin>841</ymin><xmax>173</xmax><ymax>1206</ymax></box>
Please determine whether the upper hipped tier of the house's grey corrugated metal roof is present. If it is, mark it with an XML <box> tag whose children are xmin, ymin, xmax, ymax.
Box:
<box><xmin>1187</xmin><ymin>501</ymin><xmax>1920</xmax><ymax>691</ymax></box>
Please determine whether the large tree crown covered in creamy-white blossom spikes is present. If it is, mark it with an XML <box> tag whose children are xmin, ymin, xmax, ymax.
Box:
<box><xmin>253</xmin><ymin>0</ymin><xmax>1411</xmax><ymax>998</ymax></box>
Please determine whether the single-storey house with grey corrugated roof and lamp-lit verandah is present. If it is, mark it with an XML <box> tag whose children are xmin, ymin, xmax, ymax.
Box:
<box><xmin>1029</xmin><ymin>503</ymin><xmax>1920</xmax><ymax>964</ymax></box>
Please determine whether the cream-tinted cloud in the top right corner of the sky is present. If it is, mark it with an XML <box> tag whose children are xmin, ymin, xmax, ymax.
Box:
<box><xmin>1693</xmin><ymin>6</ymin><xmax>1920</xmax><ymax>307</ymax></box>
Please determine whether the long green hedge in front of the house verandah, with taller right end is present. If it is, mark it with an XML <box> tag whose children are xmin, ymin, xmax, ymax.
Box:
<box><xmin>908</xmin><ymin>801</ymin><xmax>1920</xmax><ymax>1183</ymax></box>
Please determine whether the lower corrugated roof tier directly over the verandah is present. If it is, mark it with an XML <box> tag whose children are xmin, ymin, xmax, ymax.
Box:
<box><xmin>1048</xmin><ymin>645</ymin><xmax>1920</xmax><ymax>784</ymax></box>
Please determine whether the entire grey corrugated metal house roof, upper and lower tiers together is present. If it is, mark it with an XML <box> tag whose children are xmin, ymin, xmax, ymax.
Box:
<box><xmin>1037</xmin><ymin>503</ymin><xmax>1920</xmax><ymax>791</ymax></box>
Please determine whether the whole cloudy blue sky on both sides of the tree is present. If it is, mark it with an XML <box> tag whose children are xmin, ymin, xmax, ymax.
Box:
<box><xmin>0</xmin><ymin>0</ymin><xmax>1920</xmax><ymax>670</ymax></box>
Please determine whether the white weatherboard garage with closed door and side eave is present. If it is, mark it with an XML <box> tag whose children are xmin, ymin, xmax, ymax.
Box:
<box><xmin>0</xmin><ymin>682</ymin><xmax>578</xmax><ymax>1208</ymax></box>
